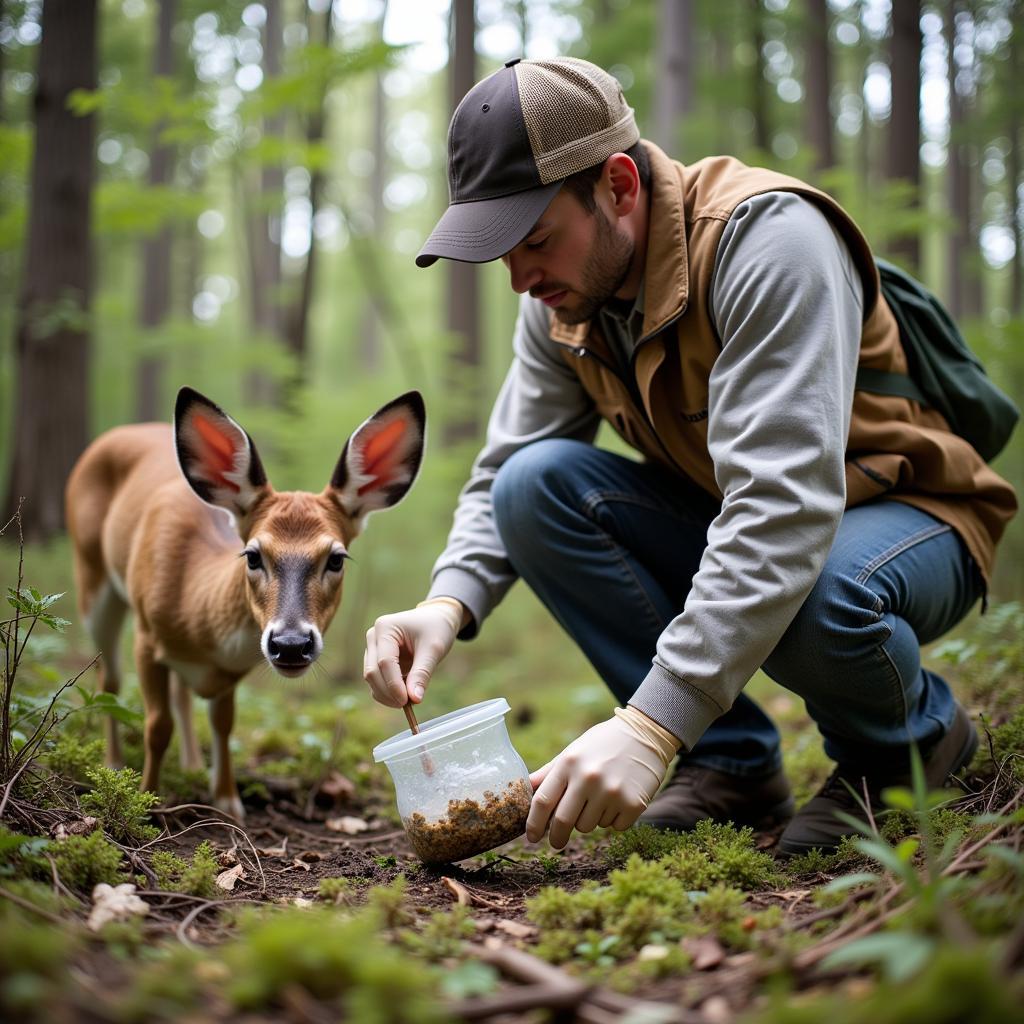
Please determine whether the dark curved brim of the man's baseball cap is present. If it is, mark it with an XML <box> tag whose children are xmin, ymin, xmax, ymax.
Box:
<box><xmin>416</xmin><ymin>181</ymin><xmax>562</xmax><ymax>266</ymax></box>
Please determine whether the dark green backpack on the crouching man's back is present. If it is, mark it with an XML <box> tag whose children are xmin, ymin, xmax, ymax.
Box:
<box><xmin>856</xmin><ymin>259</ymin><xmax>1020</xmax><ymax>462</ymax></box>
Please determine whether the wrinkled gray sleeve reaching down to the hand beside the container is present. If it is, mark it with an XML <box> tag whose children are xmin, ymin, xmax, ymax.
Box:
<box><xmin>630</xmin><ymin>193</ymin><xmax>863</xmax><ymax>750</ymax></box>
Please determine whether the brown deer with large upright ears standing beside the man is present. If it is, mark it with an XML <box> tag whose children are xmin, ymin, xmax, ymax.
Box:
<box><xmin>66</xmin><ymin>387</ymin><xmax>426</xmax><ymax>820</ymax></box>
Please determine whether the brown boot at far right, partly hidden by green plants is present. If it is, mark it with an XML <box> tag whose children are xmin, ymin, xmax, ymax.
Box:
<box><xmin>778</xmin><ymin>706</ymin><xmax>978</xmax><ymax>857</ymax></box>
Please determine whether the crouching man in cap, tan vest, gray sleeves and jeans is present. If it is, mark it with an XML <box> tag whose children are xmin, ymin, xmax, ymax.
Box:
<box><xmin>365</xmin><ymin>58</ymin><xmax>1016</xmax><ymax>855</ymax></box>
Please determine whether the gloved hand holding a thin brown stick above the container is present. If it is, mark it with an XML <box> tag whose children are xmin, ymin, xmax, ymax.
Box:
<box><xmin>362</xmin><ymin>597</ymin><xmax>466</xmax><ymax>708</ymax></box>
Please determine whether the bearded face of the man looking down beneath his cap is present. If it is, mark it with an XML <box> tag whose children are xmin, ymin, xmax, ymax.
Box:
<box><xmin>502</xmin><ymin>188</ymin><xmax>634</xmax><ymax>324</ymax></box>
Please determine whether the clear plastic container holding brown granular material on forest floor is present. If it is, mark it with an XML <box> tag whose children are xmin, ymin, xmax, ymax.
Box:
<box><xmin>374</xmin><ymin>697</ymin><xmax>534</xmax><ymax>864</ymax></box>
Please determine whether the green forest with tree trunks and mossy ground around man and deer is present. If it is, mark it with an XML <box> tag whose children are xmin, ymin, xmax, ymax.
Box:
<box><xmin>0</xmin><ymin>0</ymin><xmax>1024</xmax><ymax>1024</ymax></box>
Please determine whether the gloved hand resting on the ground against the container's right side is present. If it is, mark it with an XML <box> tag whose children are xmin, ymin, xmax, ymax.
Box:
<box><xmin>526</xmin><ymin>707</ymin><xmax>680</xmax><ymax>850</ymax></box>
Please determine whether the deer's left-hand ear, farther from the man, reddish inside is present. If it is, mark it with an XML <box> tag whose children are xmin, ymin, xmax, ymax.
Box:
<box><xmin>174</xmin><ymin>387</ymin><xmax>269</xmax><ymax>516</ymax></box>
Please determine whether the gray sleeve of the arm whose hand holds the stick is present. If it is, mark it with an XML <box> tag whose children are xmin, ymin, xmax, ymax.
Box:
<box><xmin>429</xmin><ymin>296</ymin><xmax>599</xmax><ymax>639</ymax></box>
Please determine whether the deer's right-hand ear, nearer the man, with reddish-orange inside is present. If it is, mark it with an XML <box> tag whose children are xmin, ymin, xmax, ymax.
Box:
<box><xmin>330</xmin><ymin>391</ymin><xmax>427</xmax><ymax>521</ymax></box>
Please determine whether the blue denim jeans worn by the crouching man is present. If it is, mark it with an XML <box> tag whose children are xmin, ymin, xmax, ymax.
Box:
<box><xmin>493</xmin><ymin>439</ymin><xmax>981</xmax><ymax>775</ymax></box>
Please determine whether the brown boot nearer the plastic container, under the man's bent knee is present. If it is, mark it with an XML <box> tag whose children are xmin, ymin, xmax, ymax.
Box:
<box><xmin>637</xmin><ymin>762</ymin><xmax>794</xmax><ymax>831</ymax></box>
